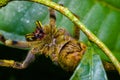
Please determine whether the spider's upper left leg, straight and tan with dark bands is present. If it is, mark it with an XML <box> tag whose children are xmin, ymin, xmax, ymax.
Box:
<box><xmin>0</xmin><ymin>34</ymin><xmax>29</xmax><ymax>48</ymax></box>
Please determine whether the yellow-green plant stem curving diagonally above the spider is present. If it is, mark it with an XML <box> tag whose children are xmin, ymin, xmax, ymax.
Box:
<box><xmin>30</xmin><ymin>0</ymin><xmax>120</xmax><ymax>74</ymax></box>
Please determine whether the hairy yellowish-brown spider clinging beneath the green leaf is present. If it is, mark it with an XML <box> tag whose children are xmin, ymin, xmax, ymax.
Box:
<box><xmin>0</xmin><ymin>8</ymin><xmax>86</xmax><ymax>71</ymax></box>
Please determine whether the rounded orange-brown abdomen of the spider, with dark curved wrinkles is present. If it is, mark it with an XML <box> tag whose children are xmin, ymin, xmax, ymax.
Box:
<box><xmin>58</xmin><ymin>40</ymin><xmax>86</xmax><ymax>71</ymax></box>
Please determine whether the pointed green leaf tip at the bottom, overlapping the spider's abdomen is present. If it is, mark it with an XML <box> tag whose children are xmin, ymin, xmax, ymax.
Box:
<box><xmin>70</xmin><ymin>47</ymin><xmax>107</xmax><ymax>80</ymax></box>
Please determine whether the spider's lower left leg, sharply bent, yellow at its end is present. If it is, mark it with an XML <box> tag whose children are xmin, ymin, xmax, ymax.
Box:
<box><xmin>0</xmin><ymin>50</ymin><xmax>35</xmax><ymax>69</ymax></box>
